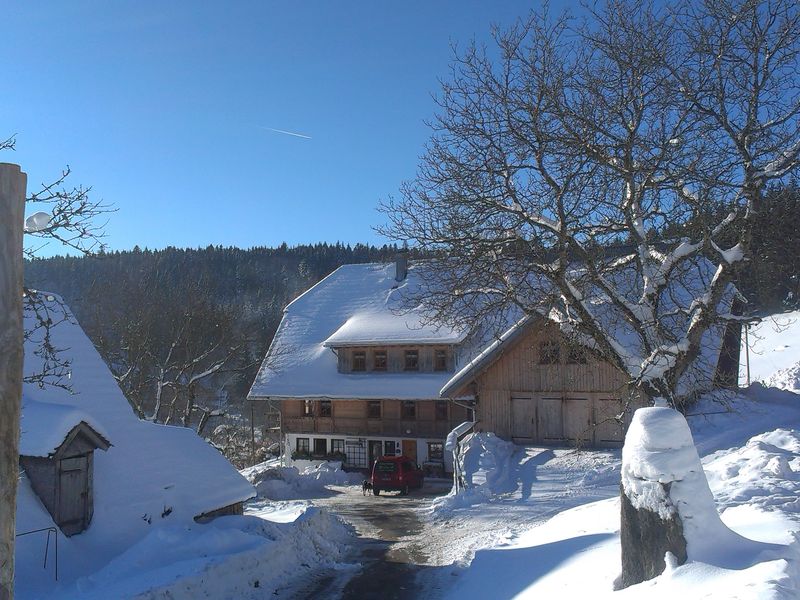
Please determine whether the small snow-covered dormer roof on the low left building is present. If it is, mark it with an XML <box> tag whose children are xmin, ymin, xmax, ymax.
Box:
<box><xmin>19</xmin><ymin>398</ymin><xmax>109</xmax><ymax>457</ymax></box>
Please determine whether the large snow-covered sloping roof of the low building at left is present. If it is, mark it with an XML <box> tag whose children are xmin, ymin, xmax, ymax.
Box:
<box><xmin>17</xmin><ymin>297</ymin><xmax>255</xmax><ymax>595</ymax></box>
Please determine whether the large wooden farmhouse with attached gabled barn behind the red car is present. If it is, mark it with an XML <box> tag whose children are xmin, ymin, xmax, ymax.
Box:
<box><xmin>248</xmin><ymin>254</ymin><xmax>738</xmax><ymax>471</ymax></box>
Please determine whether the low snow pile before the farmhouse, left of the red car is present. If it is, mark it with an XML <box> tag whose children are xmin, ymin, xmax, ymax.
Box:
<box><xmin>241</xmin><ymin>460</ymin><xmax>363</xmax><ymax>500</ymax></box>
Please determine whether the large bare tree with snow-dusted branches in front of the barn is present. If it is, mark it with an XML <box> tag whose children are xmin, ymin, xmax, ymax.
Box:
<box><xmin>383</xmin><ymin>0</ymin><xmax>800</xmax><ymax>405</ymax></box>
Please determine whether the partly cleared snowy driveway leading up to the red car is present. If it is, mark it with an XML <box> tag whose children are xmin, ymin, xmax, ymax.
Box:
<box><xmin>307</xmin><ymin>447</ymin><xmax>619</xmax><ymax>600</ymax></box>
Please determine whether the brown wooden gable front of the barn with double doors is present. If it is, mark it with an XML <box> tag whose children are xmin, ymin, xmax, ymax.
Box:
<box><xmin>460</xmin><ymin>320</ymin><xmax>641</xmax><ymax>447</ymax></box>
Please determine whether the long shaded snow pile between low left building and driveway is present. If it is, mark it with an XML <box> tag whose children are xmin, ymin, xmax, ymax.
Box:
<box><xmin>65</xmin><ymin>505</ymin><xmax>354</xmax><ymax>600</ymax></box>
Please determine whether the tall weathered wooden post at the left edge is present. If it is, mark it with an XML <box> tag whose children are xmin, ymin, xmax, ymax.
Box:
<box><xmin>0</xmin><ymin>163</ymin><xmax>27</xmax><ymax>600</ymax></box>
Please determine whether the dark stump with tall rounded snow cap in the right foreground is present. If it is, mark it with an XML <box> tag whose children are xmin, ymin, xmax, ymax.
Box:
<box><xmin>620</xmin><ymin>407</ymin><xmax>708</xmax><ymax>588</ymax></box>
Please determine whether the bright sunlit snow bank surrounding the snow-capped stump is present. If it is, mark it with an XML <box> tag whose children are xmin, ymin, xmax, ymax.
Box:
<box><xmin>442</xmin><ymin>385</ymin><xmax>800</xmax><ymax>600</ymax></box>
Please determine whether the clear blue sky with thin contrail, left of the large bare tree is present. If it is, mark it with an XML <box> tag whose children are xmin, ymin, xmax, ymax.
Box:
<box><xmin>0</xmin><ymin>0</ymin><xmax>556</xmax><ymax>255</ymax></box>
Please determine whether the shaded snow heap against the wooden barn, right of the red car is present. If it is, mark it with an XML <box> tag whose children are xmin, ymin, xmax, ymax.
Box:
<box><xmin>433</xmin><ymin>433</ymin><xmax>517</xmax><ymax>513</ymax></box>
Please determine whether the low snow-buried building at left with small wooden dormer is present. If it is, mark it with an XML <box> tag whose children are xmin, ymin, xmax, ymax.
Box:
<box><xmin>16</xmin><ymin>295</ymin><xmax>255</xmax><ymax>597</ymax></box>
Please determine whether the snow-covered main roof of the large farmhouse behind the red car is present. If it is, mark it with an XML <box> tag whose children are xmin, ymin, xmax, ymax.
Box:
<box><xmin>250</xmin><ymin>263</ymin><xmax>467</xmax><ymax>399</ymax></box>
